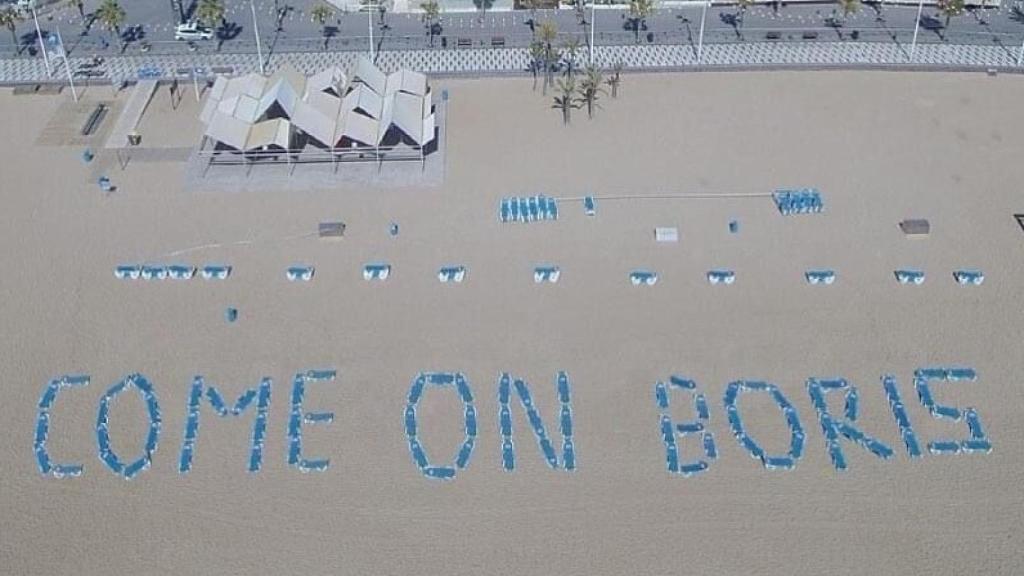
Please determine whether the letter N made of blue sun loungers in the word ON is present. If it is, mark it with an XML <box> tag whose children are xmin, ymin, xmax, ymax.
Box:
<box><xmin>498</xmin><ymin>372</ymin><xmax>577</xmax><ymax>471</ymax></box>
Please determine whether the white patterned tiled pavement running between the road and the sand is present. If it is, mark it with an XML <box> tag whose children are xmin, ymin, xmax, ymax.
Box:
<box><xmin>0</xmin><ymin>42</ymin><xmax>1020</xmax><ymax>84</ymax></box>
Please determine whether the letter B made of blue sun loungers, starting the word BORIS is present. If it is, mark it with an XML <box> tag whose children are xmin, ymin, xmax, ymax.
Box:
<box><xmin>654</xmin><ymin>376</ymin><xmax>718</xmax><ymax>477</ymax></box>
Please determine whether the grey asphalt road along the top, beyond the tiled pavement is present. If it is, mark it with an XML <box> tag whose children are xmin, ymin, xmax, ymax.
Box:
<box><xmin>0</xmin><ymin>0</ymin><xmax>1024</xmax><ymax>56</ymax></box>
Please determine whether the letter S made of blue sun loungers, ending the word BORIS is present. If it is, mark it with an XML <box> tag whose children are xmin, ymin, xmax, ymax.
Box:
<box><xmin>913</xmin><ymin>368</ymin><xmax>992</xmax><ymax>454</ymax></box>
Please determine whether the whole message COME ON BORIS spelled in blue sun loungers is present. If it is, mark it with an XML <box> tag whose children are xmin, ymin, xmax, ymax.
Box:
<box><xmin>33</xmin><ymin>368</ymin><xmax>992</xmax><ymax>480</ymax></box>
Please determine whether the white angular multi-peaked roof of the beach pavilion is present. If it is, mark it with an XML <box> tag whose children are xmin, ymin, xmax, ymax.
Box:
<box><xmin>200</xmin><ymin>56</ymin><xmax>435</xmax><ymax>151</ymax></box>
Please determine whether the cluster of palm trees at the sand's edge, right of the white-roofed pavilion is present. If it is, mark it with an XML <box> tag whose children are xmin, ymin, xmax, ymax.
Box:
<box><xmin>529</xmin><ymin>20</ymin><xmax>623</xmax><ymax>124</ymax></box>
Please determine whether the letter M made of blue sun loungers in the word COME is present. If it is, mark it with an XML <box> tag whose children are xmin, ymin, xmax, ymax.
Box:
<box><xmin>178</xmin><ymin>376</ymin><xmax>270</xmax><ymax>474</ymax></box>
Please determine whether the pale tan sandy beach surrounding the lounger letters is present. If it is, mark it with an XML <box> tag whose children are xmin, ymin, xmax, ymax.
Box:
<box><xmin>0</xmin><ymin>72</ymin><xmax>1024</xmax><ymax>576</ymax></box>
